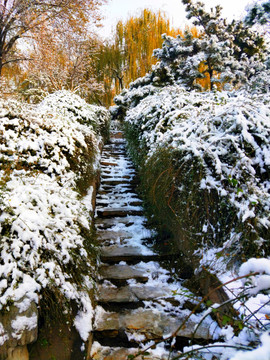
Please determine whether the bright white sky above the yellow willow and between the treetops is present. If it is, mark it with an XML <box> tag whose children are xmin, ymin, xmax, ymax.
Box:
<box><xmin>98</xmin><ymin>0</ymin><xmax>254</xmax><ymax>38</ymax></box>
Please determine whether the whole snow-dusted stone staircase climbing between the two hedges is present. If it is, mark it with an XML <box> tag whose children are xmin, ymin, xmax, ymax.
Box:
<box><xmin>90</xmin><ymin>131</ymin><xmax>213</xmax><ymax>360</ymax></box>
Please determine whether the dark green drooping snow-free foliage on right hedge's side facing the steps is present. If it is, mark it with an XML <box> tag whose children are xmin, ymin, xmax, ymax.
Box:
<box><xmin>125</xmin><ymin>142</ymin><xmax>236</xmax><ymax>262</ymax></box>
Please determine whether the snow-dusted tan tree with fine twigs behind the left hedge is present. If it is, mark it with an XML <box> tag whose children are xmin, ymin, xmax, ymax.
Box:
<box><xmin>20</xmin><ymin>24</ymin><xmax>102</xmax><ymax>101</ymax></box>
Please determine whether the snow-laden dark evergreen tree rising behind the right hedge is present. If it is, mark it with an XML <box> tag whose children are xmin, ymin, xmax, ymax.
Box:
<box><xmin>152</xmin><ymin>0</ymin><xmax>265</xmax><ymax>90</ymax></box>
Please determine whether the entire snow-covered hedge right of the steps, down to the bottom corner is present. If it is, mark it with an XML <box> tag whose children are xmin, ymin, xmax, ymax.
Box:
<box><xmin>112</xmin><ymin>76</ymin><xmax>270</xmax><ymax>360</ymax></box>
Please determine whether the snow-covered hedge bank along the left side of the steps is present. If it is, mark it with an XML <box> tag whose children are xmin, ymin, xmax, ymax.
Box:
<box><xmin>0</xmin><ymin>91</ymin><xmax>109</xmax><ymax>359</ymax></box>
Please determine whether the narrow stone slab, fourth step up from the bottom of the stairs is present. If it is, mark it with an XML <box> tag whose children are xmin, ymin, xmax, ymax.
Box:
<box><xmin>99</xmin><ymin>264</ymin><xmax>148</xmax><ymax>281</ymax></box>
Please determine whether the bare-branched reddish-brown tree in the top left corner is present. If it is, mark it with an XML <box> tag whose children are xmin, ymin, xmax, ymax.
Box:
<box><xmin>0</xmin><ymin>0</ymin><xmax>107</xmax><ymax>75</ymax></box>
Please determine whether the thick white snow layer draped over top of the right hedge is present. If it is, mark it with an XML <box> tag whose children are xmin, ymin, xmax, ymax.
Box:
<box><xmin>116</xmin><ymin>83</ymin><xmax>270</xmax><ymax>256</ymax></box>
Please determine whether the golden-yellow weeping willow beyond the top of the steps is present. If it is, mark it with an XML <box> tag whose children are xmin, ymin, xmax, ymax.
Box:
<box><xmin>96</xmin><ymin>9</ymin><xmax>181</xmax><ymax>105</ymax></box>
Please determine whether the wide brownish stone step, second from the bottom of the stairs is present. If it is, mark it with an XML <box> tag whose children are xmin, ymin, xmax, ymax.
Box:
<box><xmin>94</xmin><ymin>305</ymin><xmax>213</xmax><ymax>340</ymax></box>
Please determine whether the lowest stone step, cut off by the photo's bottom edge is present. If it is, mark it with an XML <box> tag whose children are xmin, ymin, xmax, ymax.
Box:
<box><xmin>90</xmin><ymin>341</ymin><xmax>170</xmax><ymax>360</ymax></box>
